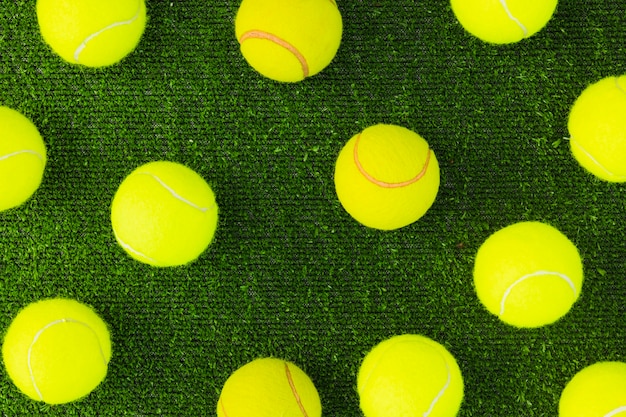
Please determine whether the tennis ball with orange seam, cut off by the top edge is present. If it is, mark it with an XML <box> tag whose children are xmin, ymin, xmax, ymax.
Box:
<box><xmin>235</xmin><ymin>0</ymin><xmax>342</xmax><ymax>82</ymax></box>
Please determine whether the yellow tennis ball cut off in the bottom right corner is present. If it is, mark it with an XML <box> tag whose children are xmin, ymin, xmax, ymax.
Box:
<box><xmin>559</xmin><ymin>362</ymin><xmax>626</xmax><ymax>417</ymax></box>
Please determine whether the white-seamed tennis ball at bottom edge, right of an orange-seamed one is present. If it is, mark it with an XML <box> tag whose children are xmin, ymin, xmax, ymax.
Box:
<box><xmin>357</xmin><ymin>334</ymin><xmax>463</xmax><ymax>417</ymax></box>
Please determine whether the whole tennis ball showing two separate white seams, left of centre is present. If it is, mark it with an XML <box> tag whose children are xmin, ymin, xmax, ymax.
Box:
<box><xmin>111</xmin><ymin>161</ymin><xmax>217</xmax><ymax>266</ymax></box>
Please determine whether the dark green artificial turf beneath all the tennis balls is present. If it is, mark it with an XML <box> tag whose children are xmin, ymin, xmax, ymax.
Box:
<box><xmin>0</xmin><ymin>0</ymin><xmax>626</xmax><ymax>417</ymax></box>
